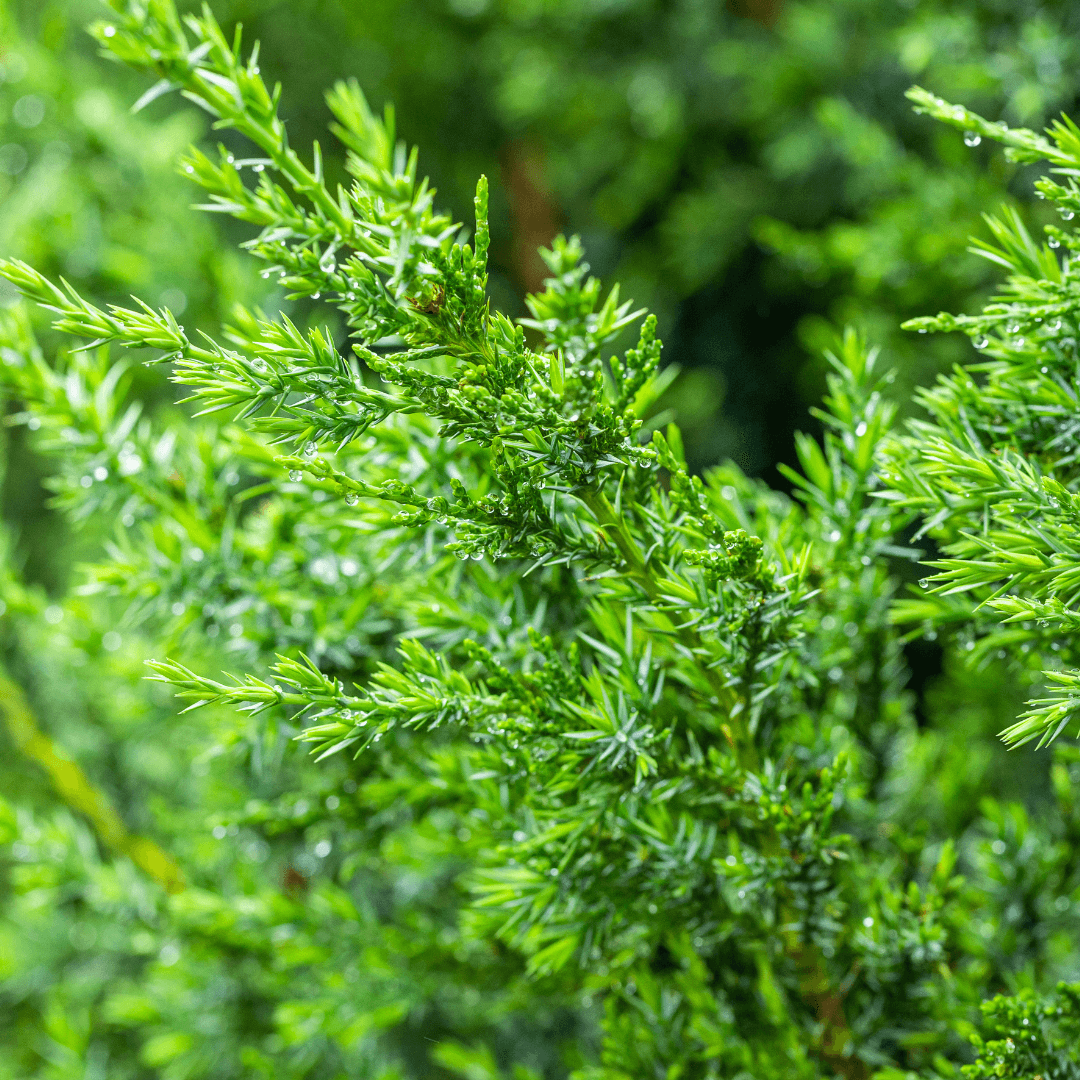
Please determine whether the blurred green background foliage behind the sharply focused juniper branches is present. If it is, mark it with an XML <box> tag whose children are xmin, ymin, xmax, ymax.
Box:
<box><xmin>6</xmin><ymin>0</ymin><xmax>1080</xmax><ymax>1080</ymax></box>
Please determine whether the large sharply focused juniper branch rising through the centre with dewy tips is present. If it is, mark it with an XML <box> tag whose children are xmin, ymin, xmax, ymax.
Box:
<box><xmin>0</xmin><ymin>0</ymin><xmax>980</xmax><ymax>1080</ymax></box>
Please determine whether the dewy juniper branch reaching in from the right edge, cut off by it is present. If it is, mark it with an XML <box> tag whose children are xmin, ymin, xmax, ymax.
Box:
<box><xmin>886</xmin><ymin>89</ymin><xmax>1080</xmax><ymax>746</ymax></box>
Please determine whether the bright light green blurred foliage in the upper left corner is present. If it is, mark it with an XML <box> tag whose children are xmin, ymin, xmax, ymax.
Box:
<box><xmin>0</xmin><ymin>0</ymin><xmax>257</xmax><ymax>589</ymax></box>
